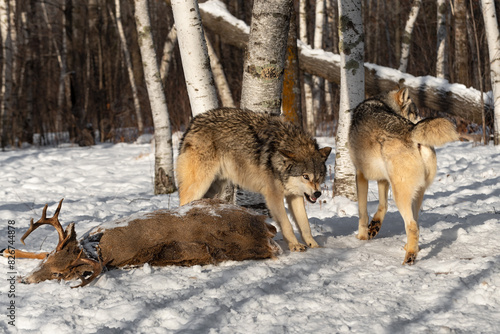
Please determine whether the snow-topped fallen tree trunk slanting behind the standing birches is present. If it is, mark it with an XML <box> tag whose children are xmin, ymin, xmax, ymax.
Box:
<box><xmin>200</xmin><ymin>2</ymin><xmax>493</xmax><ymax>123</ymax></box>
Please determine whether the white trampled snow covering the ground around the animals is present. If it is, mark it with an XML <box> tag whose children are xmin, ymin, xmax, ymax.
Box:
<box><xmin>0</xmin><ymin>138</ymin><xmax>500</xmax><ymax>334</ymax></box>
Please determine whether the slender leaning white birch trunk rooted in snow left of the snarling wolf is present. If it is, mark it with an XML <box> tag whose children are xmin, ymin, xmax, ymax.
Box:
<box><xmin>134</xmin><ymin>0</ymin><xmax>175</xmax><ymax>194</ymax></box>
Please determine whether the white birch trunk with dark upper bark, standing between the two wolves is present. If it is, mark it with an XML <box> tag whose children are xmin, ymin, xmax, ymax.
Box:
<box><xmin>333</xmin><ymin>0</ymin><xmax>365</xmax><ymax>200</ymax></box>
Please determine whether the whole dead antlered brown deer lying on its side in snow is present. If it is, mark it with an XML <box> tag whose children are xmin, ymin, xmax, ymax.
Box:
<box><xmin>4</xmin><ymin>199</ymin><xmax>281</xmax><ymax>286</ymax></box>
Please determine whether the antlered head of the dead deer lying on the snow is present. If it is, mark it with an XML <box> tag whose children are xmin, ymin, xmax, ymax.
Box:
<box><xmin>21</xmin><ymin>199</ymin><xmax>102</xmax><ymax>287</ymax></box>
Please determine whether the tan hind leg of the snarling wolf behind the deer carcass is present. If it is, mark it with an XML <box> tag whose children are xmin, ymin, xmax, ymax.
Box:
<box><xmin>177</xmin><ymin>150</ymin><xmax>220</xmax><ymax>205</ymax></box>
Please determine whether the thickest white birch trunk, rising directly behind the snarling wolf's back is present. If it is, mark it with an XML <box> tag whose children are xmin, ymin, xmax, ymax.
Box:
<box><xmin>241</xmin><ymin>0</ymin><xmax>293</xmax><ymax>115</ymax></box>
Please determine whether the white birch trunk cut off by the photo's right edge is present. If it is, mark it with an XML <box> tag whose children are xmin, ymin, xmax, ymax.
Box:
<box><xmin>481</xmin><ymin>0</ymin><xmax>500</xmax><ymax>145</ymax></box>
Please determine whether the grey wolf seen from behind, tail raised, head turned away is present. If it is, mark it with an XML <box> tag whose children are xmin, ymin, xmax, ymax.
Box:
<box><xmin>349</xmin><ymin>88</ymin><xmax>458</xmax><ymax>264</ymax></box>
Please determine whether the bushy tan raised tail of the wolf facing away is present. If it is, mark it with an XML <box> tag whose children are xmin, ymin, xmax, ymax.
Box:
<box><xmin>411</xmin><ymin>118</ymin><xmax>458</xmax><ymax>146</ymax></box>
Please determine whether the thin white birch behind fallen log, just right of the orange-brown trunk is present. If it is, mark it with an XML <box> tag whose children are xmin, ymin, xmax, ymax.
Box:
<box><xmin>299</xmin><ymin>0</ymin><xmax>316</xmax><ymax>135</ymax></box>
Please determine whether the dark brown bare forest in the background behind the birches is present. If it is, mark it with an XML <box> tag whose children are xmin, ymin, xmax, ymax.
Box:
<box><xmin>1</xmin><ymin>0</ymin><xmax>500</xmax><ymax>148</ymax></box>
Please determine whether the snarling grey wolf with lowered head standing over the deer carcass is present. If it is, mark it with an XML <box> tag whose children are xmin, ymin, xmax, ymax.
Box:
<box><xmin>176</xmin><ymin>108</ymin><xmax>332</xmax><ymax>251</ymax></box>
